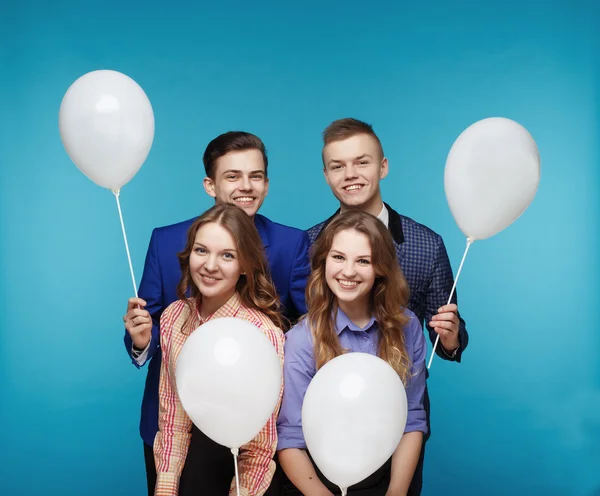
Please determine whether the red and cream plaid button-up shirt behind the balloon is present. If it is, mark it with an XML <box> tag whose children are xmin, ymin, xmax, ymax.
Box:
<box><xmin>154</xmin><ymin>293</ymin><xmax>284</xmax><ymax>496</ymax></box>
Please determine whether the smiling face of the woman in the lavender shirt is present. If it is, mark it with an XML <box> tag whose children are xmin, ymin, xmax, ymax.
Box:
<box><xmin>325</xmin><ymin>229</ymin><xmax>375</xmax><ymax>313</ymax></box>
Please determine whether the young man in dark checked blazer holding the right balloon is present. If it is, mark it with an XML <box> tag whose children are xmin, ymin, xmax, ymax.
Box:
<box><xmin>308</xmin><ymin>118</ymin><xmax>469</xmax><ymax>495</ymax></box>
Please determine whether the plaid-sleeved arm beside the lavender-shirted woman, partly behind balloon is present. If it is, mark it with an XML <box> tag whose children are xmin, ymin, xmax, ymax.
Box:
<box><xmin>229</xmin><ymin>329</ymin><xmax>284</xmax><ymax>496</ymax></box>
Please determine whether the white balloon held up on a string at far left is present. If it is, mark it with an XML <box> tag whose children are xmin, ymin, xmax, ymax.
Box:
<box><xmin>58</xmin><ymin>70</ymin><xmax>154</xmax><ymax>189</ymax></box>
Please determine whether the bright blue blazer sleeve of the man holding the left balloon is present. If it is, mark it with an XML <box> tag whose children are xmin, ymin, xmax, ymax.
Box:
<box><xmin>124</xmin><ymin>229</ymin><xmax>164</xmax><ymax>368</ymax></box>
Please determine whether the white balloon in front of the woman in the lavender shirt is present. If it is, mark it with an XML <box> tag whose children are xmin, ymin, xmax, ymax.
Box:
<box><xmin>302</xmin><ymin>353</ymin><xmax>408</xmax><ymax>490</ymax></box>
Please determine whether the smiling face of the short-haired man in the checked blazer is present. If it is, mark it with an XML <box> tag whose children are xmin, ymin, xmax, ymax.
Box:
<box><xmin>323</xmin><ymin>134</ymin><xmax>388</xmax><ymax>216</ymax></box>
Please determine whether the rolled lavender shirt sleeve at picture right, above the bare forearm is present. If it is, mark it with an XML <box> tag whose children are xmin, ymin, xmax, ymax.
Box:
<box><xmin>404</xmin><ymin>312</ymin><xmax>427</xmax><ymax>434</ymax></box>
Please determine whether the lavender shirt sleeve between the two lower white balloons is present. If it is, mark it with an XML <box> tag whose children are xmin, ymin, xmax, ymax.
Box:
<box><xmin>277</xmin><ymin>319</ymin><xmax>316</xmax><ymax>450</ymax></box>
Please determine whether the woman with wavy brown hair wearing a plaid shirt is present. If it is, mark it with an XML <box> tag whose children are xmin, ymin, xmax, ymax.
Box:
<box><xmin>154</xmin><ymin>204</ymin><xmax>284</xmax><ymax>496</ymax></box>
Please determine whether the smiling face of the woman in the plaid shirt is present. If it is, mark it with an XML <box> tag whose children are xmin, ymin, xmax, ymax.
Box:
<box><xmin>189</xmin><ymin>222</ymin><xmax>242</xmax><ymax>308</ymax></box>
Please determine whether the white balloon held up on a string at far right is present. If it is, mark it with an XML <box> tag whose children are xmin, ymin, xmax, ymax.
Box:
<box><xmin>444</xmin><ymin>117</ymin><xmax>540</xmax><ymax>241</ymax></box>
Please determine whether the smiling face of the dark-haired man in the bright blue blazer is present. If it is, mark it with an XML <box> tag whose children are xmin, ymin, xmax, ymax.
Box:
<box><xmin>204</xmin><ymin>149</ymin><xmax>269</xmax><ymax>217</ymax></box>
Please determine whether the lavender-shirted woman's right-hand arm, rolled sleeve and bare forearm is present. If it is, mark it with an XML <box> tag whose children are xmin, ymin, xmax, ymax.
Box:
<box><xmin>387</xmin><ymin>315</ymin><xmax>427</xmax><ymax>496</ymax></box>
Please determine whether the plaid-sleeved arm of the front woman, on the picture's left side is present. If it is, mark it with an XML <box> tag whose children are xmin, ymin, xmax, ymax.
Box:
<box><xmin>154</xmin><ymin>306</ymin><xmax>192</xmax><ymax>496</ymax></box>
